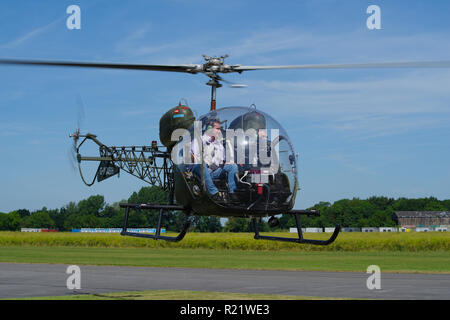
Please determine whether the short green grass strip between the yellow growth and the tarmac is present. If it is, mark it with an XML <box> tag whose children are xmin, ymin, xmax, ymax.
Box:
<box><xmin>0</xmin><ymin>246</ymin><xmax>450</xmax><ymax>273</ymax></box>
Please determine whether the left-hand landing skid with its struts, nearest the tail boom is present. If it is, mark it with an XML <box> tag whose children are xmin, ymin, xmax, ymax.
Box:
<box><xmin>120</xmin><ymin>203</ymin><xmax>191</xmax><ymax>242</ymax></box>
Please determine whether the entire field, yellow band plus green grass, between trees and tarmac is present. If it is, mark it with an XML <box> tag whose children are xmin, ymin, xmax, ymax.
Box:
<box><xmin>0</xmin><ymin>232</ymin><xmax>450</xmax><ymax>273</ymax></box>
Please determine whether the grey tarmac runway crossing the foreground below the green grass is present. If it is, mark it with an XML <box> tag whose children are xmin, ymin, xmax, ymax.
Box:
<box><xmin>0</xmin><ymin>263</ymin><xmax>450</xmax><ymax>300</ymax></box>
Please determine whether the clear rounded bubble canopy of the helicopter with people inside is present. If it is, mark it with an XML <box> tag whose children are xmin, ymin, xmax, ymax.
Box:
<box><xmin>172</xmin><ymin>107</ymin><xmax>298</xmax><ymax>211</ymax></box>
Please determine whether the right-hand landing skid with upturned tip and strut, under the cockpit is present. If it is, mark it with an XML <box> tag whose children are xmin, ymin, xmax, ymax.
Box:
<box><xmin>253</xmin><ymin>210</ymin><xmax>341</xmax><ymax>246</ymax></box>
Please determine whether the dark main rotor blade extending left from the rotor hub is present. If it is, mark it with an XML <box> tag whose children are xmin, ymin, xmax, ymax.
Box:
<box><xmin>0</xmin><ymin>59</ymin><xmax>201</xmax><ymax>73</ymax></box>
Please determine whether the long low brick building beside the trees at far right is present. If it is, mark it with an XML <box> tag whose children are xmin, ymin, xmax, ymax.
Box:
<box><xmin>393</xmin><ymin>211</ymin><xmax>450</xmax><ymax>228</ymax></box>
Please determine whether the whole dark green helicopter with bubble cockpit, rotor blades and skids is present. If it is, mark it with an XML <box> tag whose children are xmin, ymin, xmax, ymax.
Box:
<box><xmin>0</xmin><ymin>55</ymin><xmax>450</xmax><ymax>245</ymax></box>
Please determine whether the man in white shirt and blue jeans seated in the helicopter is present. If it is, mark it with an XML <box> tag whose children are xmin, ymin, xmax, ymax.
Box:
<box><xmin>192</xmin><ymin>119</ymin><xmax>238</xmax><ymax>201</ymax></box>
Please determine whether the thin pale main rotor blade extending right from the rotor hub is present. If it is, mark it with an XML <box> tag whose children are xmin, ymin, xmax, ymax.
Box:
<box><xmin>233</xmin><ymin>61</ymin><xmax>450</xmax><ymax>72</ymax></box>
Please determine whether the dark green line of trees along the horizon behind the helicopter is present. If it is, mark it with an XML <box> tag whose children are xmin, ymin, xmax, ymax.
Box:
<box><xmin>0</xmin><ymin>186</ymin><xmax>450</xmax><ymax>232</ymax></box>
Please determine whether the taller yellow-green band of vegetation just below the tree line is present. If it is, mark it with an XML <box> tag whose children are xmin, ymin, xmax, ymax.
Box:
<box><xmin>0</xmin><ymin>232</ymin><xmax>450</xmax><ymax>252</ymax></box>
